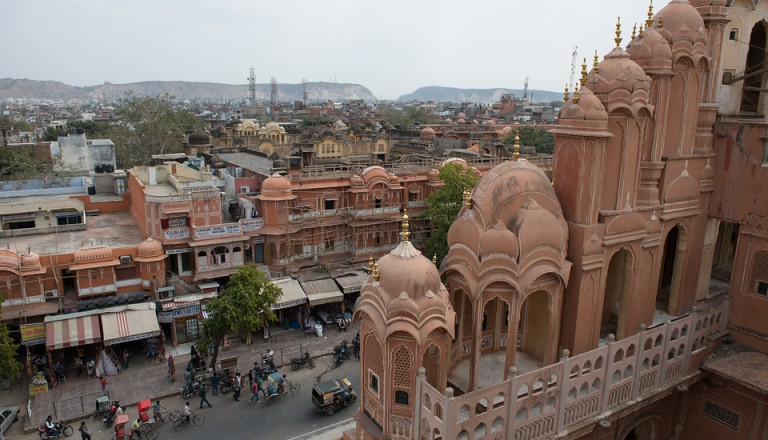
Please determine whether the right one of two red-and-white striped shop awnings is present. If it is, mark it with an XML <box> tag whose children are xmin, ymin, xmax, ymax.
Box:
<box><xmin>101</xmin><ymin>303</ymin><xmax>160</xmax><ymax>345</ymax></box>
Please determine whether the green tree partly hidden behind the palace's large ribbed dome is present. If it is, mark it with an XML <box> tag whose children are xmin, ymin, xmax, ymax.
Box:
<box><xmin>420</xmin><ymin>162</ymin><xmax>479</xmax><ymax>264</ymax></box>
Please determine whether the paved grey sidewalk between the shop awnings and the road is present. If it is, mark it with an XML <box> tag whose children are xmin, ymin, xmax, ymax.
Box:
<box><xmin>11</xmin><ymin>322</ymin><xmax>360</xmax><ymax>438</ymax></box>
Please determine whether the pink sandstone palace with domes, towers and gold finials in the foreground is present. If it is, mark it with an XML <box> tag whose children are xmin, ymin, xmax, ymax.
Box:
<box><xmin>345</xmin><ymin>0</ymin><xmax>768</xmax><ymax>440</ymax></box>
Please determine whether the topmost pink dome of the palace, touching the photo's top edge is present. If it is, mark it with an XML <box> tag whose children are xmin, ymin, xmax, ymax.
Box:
<box><xmin>652</xmin><ymin>0</ymin><xmax>707</xmax><ymax>63</ymax></box>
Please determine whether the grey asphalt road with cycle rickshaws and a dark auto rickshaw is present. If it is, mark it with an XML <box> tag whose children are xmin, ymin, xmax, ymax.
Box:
<box><xmin>119</xmin><ymin>356</ymin><xmax>360</xmax><ymax>440</ymax></box>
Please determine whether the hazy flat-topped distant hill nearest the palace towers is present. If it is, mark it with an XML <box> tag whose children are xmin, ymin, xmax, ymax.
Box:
<box><xmin>398</xmin><ymin>86</ymin><xmax>563</xmax><ymax>104</ymax></box>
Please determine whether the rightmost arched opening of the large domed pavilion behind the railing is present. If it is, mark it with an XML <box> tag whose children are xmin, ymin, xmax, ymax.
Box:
<box><xmin>517</xmin><ymin>290</ymin><xmax>552</xmax><ymax>366</ymax></box>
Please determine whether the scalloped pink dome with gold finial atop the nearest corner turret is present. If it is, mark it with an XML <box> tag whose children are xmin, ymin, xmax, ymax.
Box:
<box><xmin>354</xmin><ymin>214</ymin><xmax>455</xmax><ymax>344</ymax></box>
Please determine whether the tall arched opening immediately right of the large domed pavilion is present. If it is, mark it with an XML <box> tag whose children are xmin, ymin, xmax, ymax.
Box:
<box><xmin>600</xmin><ymin>248</ymin><xmax>634</xmax><ymax>339</ymax></box>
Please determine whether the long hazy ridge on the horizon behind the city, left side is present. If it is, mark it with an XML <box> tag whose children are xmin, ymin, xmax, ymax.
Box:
<box><xmin>0</xmin><ymin>78</ymin><xmax>377</xmax><ymax>102</ymax></box>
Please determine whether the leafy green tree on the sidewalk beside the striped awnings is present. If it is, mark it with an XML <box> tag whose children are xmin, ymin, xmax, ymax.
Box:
<box><xmin>203</xmin><ymin>266</ymin><xmax>283</xmax><ymax>365</ymax></box>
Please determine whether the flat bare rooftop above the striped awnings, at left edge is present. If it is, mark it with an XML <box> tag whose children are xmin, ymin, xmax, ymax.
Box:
<box><xmin>0</xmin><ymin>212</ymin><xmax>144</xmax><ymax>255</ymax></box>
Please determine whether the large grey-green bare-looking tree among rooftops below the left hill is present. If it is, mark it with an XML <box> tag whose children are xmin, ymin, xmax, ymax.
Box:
<box><xmin>106</xmin><ymin>92</ymin><xmax>205</xmax><ymax>168</ymax></box>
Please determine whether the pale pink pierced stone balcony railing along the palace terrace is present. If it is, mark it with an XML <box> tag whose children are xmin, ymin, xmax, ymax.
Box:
<box><xmin>414</xmin><ymin>302</ymin><xmax>728</xmax><ymax>440</ymax></box>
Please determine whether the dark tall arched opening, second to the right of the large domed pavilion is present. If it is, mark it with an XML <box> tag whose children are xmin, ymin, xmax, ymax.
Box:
<box><xmin>656</xmin><ymin>226</ymin><xmax>686</xmax><ymax>315</ymax></box>
